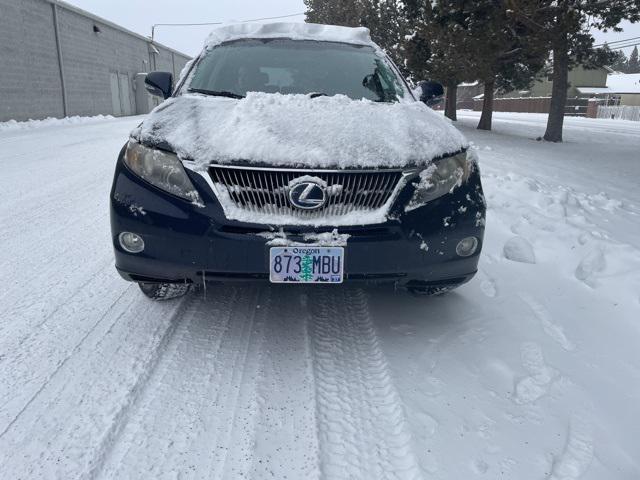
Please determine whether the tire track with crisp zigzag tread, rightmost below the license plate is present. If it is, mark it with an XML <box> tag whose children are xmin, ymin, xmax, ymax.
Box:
<box><xmin>310</xmin><ymin>289</ymin><xmax>422</xmax><ymax>480</ymax></box>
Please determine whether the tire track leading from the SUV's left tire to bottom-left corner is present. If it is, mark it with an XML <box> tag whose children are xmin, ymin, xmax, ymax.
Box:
<box><xmin>0</xmin><ymin>291</ymin><xmax>189</xmax><ymax>479</ymax></box>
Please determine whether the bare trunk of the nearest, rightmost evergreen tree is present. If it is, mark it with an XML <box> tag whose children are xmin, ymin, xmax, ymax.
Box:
<box><xmin>544</xmin><ymin>33</ymin><xmax>569</xmax><ymax>142</ymax></box>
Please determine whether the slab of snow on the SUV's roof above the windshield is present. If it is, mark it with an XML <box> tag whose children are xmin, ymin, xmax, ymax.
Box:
<box><xmin>204</xmin><ymin>22</ymin><xmax>378</xmax><ymax>49</ymax></box>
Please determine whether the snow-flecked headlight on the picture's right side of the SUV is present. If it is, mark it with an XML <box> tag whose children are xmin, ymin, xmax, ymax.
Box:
<box><xmin>407</xmin><ymin>152</ymin><xmax>474</xmax><ymax>210</ymax></box>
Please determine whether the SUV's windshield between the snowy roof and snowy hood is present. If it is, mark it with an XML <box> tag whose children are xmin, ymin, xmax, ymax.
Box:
<box><xmin>187</xmin><ymin>39</ymin><xmax>404</xmax><ymax>102</ymax></box>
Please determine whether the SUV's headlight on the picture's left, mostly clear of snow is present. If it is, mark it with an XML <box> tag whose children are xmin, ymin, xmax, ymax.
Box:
<box><xmin>124</xmin><ymin>140</ymin><xmax>202</xmax><ymax>204</ymax></box>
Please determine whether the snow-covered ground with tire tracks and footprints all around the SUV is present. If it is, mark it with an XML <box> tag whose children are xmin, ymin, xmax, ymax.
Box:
<box><xmin>0</xmin><ymin>112</ymin><xmax>640</xmax><ymax>480</ymax></box>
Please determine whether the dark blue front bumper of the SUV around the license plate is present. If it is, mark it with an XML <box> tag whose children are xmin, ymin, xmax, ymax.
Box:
<box><xmin>111</xmin><ymin>146</ymin><xmax>485</xmax><ymax>286</ymax></box>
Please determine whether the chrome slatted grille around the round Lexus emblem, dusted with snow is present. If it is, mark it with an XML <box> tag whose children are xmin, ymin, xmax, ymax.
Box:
<box><xmin>209</xmin><ymin>165</ymin><xmax>402</xmax><ymax>219</ymax></box>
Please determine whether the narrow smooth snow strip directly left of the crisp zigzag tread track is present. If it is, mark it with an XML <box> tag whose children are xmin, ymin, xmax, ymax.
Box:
<box><xmin>250</xmin><ymin>285</ymin><xmax>320</xmax><ymax>480</ymax></box>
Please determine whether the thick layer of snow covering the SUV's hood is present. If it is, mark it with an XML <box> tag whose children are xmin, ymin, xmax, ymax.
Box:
<box><xmin>132</xmin><ymin>92</ymin><xmax>468</xmax><ymax>168</ymax></box>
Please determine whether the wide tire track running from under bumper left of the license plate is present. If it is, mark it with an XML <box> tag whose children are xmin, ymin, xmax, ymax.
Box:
<box><xmin>96</xmin><ymin>285</ymin><xmax>270</xmax><ymax>480</ymax></box>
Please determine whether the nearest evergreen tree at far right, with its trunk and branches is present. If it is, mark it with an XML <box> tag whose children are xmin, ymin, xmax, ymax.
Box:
<box><xmin>506</xmin><ymin>0</ymin><xmax>640</xmax><ymax>142</ymax></box>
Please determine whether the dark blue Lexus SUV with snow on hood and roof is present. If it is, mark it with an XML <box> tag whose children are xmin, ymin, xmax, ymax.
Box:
<box><xmin>111</xmin><ymin>23</ymin><xmax>485</xmax><ymax>299</ymax></box>
